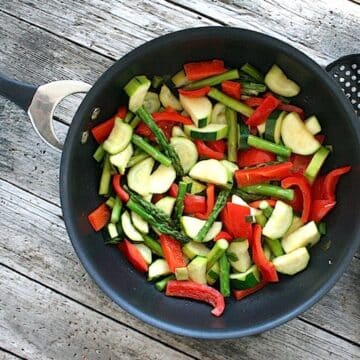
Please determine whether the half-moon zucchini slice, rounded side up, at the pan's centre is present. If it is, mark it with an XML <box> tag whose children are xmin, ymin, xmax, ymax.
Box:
<box><xmin>189</xmin><ymin>159</ymin><xmax>228</xmax><ymax>186</ymax></box>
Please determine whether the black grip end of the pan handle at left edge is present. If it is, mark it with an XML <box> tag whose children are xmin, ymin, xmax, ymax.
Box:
<box><xmin>0</xmin><ymin>73</ymin><xmax>38</xmax><ymax>111</ymax></box>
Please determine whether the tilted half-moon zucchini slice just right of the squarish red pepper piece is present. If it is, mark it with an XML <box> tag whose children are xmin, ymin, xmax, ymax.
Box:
<box><xmin>263</xmin><ymin>200</ymin><xmax>293</xmax><ymax>239</ymax></box>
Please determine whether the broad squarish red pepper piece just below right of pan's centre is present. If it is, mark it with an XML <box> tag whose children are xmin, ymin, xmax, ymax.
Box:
<box><xmin>221</xmin><ymin>202</ymin><xmax>252</xmax><ymax>241</ymax></box>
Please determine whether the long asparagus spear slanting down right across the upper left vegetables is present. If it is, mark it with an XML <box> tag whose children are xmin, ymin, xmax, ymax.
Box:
<box><xmin>136</xmin><ymin>106</ymin><xmax>184</xmax><ymax>176</ymax></box>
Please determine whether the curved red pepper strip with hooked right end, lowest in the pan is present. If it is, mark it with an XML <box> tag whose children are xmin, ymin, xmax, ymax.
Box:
<box><xmin>166</xmin><ymin>280</ymin><xmax>225</xmax><ymax>316</ymax></box>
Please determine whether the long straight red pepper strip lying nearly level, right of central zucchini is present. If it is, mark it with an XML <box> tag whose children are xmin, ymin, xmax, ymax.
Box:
<box><xmin>235</xmin><ymin>161</ymin><xmax>293</xmax><ymax>187</ymax></box>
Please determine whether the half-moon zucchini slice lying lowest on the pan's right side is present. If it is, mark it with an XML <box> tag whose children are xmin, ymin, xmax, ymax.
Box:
<box><xmin>272</xmin><ymin>247</ymin><xmax>310</xmax><ymax>275</ymax></box>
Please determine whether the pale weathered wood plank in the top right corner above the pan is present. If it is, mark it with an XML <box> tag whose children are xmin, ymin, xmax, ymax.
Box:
<box><xmin>171</xmin><ymin>0</ymin><xmax>360</xmax><ymax>65</ymax></box>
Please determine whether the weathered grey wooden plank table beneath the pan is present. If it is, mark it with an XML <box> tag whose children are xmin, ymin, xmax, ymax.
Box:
<box><xmin>0</xmin><ymin>0</ymin><xmax>360</xmax><ymax>360</ymax></box>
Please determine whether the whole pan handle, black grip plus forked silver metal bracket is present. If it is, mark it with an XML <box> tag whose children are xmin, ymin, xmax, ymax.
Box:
<box><xmin>0</xmin><ymin>73</ymin><xmax>91</xmax><ymax>151</ymax></box>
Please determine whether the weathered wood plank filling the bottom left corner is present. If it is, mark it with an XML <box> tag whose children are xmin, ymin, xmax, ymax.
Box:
<box><xmin>0</xmin><ymin>266</ymin><xmax>191</xmax><ymax>360</ymax></box>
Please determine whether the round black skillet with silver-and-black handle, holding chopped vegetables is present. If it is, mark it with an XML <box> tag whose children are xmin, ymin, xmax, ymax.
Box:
<box><xmin>0</xmin><ymin>27</ymin><xmax>360</xmax><ymax>339</ymax></box>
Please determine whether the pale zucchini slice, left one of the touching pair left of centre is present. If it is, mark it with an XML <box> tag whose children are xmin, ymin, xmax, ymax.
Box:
<box><xmin>127</xmin><ymin>157</ymin><xmax>155</xmax><ymax>196</ymax></box>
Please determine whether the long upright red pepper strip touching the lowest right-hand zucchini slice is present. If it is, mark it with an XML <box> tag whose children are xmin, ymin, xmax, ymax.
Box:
<box><xmin>252</xmin><ymin>224</ymin><xmax>279</xmax><ymax>282</ymax></box>
